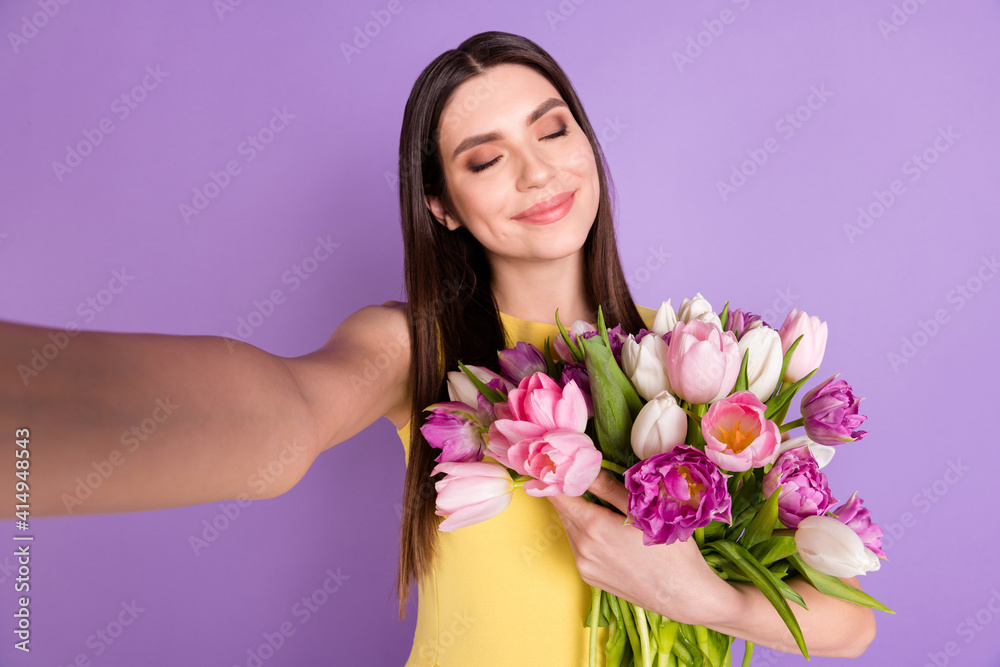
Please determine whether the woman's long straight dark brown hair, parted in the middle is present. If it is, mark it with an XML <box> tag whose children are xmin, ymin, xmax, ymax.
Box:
<box><xmin>396</xmin><ymin>31</ymin><xmax>643</xmax><ymax>618</ymax></box>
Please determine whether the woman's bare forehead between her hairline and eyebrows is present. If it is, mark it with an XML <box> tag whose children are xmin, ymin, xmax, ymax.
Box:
<box><xmin>439</xmin><ymin>64</ymin><xmax>562</xmax><ymax>146</ymax></box>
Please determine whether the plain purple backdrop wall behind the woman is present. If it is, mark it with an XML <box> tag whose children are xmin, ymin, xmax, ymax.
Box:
<box><xmin>0</xmin><ymin>0</ymin><xmax>1000</xmax><ymax>667</ymax></box>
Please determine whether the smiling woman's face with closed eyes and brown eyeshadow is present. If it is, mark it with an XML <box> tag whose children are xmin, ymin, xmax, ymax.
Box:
<box><xmin>426</xmin><ymin>65</ymin><xmax>600</xmax><ymax>260</ymax></box>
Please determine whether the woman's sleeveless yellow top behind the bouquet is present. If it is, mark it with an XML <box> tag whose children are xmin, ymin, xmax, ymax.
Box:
<box><xmin>398</xmin><ymin>306</ymin><xmax>656</xmax><ymax>667</ymax></box>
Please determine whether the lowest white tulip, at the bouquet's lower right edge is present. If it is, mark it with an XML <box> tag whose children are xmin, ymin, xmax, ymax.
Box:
<box><xmin>795</xmin><ymin>516</ymin><xmax>881</xmax><ymax>578</ymax></box>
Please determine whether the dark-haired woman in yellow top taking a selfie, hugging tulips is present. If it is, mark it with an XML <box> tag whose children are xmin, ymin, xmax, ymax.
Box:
<box><xmin>0</xmin><ymin>32</ymin><xmax>874</xmax><ymax>667</ymax></box>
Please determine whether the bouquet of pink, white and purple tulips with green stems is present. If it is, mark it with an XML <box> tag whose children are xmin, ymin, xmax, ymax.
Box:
<box><xmin>421</xmin><ymin>294</ymin><xmax>892</xmax><ymax>667</ymax></box>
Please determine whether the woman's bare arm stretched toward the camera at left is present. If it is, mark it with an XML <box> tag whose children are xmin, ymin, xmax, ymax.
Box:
<box><xmin>0</xmin><ymin>306</ymin><xmax>409</xmax><ymax>518</ymax></box>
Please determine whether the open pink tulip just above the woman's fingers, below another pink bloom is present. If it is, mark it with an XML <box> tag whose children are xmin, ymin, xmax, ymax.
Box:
<box><xmin>507</xmin><ymin>429</ymin><xmax>601</xmax><ymax>496</ymax></box>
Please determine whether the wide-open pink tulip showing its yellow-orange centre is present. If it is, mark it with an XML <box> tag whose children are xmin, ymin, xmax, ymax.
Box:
<box><xmin>701</xmin><ymin>391</ymin><xmax>781</xmax><ymax>472</ymax></box>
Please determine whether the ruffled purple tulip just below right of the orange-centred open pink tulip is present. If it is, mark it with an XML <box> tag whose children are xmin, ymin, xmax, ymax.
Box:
<box><xmin>764</xmin><ymin>447</ymin><xmax>837</xmax><ymax>528</ymax></box>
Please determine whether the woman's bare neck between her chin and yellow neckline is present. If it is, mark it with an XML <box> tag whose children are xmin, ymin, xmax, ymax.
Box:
<box><xmin>490</xmin><ymin>249</ymin><xmax>597</xmax><ymax>329</ymax></box>
